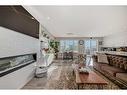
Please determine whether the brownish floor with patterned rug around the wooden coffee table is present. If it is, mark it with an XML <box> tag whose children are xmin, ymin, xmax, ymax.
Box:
<box><xmin>23</xmin><ymin>60</ymin><xmax>119</xmax><ymax>89</ymax></box>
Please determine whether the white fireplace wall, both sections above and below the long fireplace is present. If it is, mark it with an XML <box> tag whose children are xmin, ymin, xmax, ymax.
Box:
<box><xmin>0</xmin><ymin>27</ymin><xmax>39</xmax><ymax>89</ymax></box>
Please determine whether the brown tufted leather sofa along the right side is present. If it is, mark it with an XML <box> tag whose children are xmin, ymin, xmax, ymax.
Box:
<box><xmin>93</xmin><ymin>54</ymin><xmax>127</xmax><ymax>89</ymax></box>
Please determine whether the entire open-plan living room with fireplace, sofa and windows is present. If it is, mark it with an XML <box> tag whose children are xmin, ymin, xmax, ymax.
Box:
<box><xmin>0</xmin><ymin>0</ymin><xmax>127</xmax><ymax>94</ymax></box>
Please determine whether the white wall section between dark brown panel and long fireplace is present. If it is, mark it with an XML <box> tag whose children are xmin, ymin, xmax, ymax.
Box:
<box><xmin>0</xmin><ymin>26</ymin><xmax>39</xmax><ymax>58</ymax></box>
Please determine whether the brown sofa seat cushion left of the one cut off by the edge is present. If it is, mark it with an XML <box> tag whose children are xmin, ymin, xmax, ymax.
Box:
<box><xmin>101</xmin><ymin>65</ymin><xmax>125</xmax><ymax>77</ymax></box>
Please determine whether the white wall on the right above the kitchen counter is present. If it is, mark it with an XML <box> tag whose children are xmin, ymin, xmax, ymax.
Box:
<box><xmin>103</xmin><ymin>32</ymin><xmax>127</xmax><ymax>47</ymax></box>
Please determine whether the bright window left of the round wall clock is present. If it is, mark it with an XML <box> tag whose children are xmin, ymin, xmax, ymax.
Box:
<box><xmin>60</xmin><ymin>40</ymin><xmax>78</xmax><ymax>52</ymax></box>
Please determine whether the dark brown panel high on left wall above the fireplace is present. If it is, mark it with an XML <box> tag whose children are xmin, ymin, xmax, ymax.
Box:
<box><xmin>0</xmin><ymin>6</ymin><xmax>39</xmax><ymax>38</ymax></box>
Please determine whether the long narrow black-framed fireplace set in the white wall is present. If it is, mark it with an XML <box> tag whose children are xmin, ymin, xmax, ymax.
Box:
<box><xmin>0</xmin><ymin>54</ymin><xmax>36</xmax><ymax>77</ymax></box>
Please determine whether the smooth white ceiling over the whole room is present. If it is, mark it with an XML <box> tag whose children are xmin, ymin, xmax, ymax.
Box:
<box><xmin>24</xmin><ymin>5</ymin><xmax>127</xmax><ymax>37</ymax></box>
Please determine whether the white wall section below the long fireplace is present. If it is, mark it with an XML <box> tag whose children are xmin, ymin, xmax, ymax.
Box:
<box><xmin>0</xmin><ymin>62</ymin><xmax>36</xmax><ymax>89</ymax></box>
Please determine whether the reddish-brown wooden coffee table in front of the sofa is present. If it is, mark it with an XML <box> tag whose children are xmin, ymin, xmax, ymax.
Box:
<box><xmin>73</xmin><ymin>64</ymin><xmax>108</xmax><ymax>89</ymax></box>
